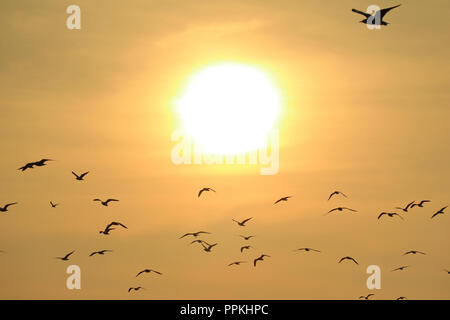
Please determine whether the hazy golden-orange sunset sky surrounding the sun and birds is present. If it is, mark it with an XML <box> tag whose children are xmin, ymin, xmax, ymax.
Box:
<box><xmin>0</xmin><ymin>0</ymin><xmax>450</xmax><ymax>299</ymax></box>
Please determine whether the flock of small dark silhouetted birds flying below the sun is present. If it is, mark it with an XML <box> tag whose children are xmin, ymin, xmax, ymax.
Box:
<box><xmin>0</xmin><ymin>159</ymin><xmax>450</xmax><ymax>300</ymax></box>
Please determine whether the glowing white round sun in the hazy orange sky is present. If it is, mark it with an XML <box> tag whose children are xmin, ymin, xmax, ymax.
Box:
<box><xmin>177</xmin><ymin>63</ymin><xmax>280</xmax><ymax>154</ymax></box>
